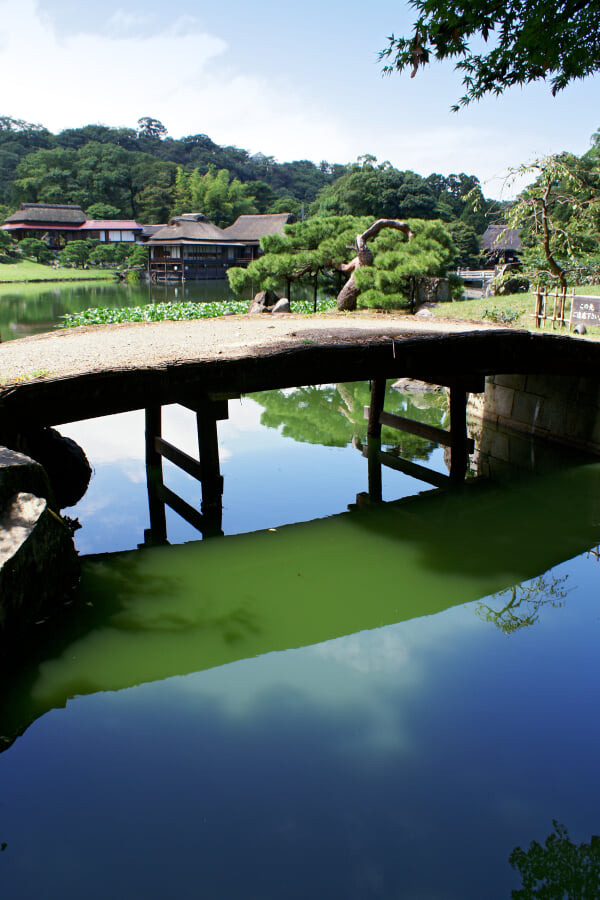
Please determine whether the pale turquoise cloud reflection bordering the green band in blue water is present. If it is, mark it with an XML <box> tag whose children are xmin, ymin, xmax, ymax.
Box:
<box><xmin>155</xmin><ymin>604</ymin><xmax>481</xmax><ymax>767</ymax></box>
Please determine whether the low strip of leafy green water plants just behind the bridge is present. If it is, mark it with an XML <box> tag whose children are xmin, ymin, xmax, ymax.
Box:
<box><xmin>58</xmin><ymin>299</ymin><xmax>335</xmax><ymax>328</ymax></box>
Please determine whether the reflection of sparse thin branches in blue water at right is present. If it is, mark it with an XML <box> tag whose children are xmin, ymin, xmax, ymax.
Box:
<box><xmin>477</xmin><ymin>573</ymin><xmax>569</xmax><ymax>634</ymax></box>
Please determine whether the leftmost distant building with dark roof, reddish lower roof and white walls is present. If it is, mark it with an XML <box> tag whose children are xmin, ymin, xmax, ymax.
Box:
<box><xmin>0</xmin><ymin>203</ymin><xmax>143</xmax><ymax>250</ymax></box>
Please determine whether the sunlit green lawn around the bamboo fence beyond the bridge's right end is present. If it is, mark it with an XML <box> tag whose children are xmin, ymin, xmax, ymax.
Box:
<box><xmin>432</xmin><ymin>284</ymin><xmax>600</xmax><ymax>338</ymax></box>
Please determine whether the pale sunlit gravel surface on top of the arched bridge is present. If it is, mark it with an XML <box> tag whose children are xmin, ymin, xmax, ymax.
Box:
<box><xmin>0</xmin><ymin>313</ymin><xmax>498</xmax><ymax>385</ymax></box>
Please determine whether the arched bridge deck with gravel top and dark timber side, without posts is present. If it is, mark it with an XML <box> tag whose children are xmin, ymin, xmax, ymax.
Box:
<box><xmin>0</xmin><ymin>313</ymin><xmax>600</xmax><ymax>426</ymax></box>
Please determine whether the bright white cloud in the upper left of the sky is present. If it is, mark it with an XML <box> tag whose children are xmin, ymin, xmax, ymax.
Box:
<box><xmin>0</xmin><ymin>0</ymin><xmax>227</xmax><ymax>130</ymax></box>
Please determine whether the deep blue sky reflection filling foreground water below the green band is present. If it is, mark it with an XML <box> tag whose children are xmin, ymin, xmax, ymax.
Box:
<box><xmin>0</xmin><ymin>557</ymin><xmax>600</xmax><ymax>900</ymax></box>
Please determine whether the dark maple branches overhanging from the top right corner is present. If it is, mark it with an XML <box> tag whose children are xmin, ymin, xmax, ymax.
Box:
<box><xmin>380</xmin><ymin>0</ymin><xmax>600</xmax><ymax>109</ymax></box>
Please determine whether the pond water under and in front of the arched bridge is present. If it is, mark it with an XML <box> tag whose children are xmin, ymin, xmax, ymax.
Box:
<box><xmin>0</xmin><ymin>284</ymin><xmax>600</xmax><ymax>900</ymax></box>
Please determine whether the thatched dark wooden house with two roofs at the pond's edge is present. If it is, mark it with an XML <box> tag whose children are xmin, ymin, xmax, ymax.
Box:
<box><xmin>146</xmin><ymin>213</ymin><xmax>296</xmax><ymax>281</ymax></box>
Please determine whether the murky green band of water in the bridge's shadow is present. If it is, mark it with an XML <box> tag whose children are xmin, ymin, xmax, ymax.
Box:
<box><xmin>18</xmin><ymin>465</ymin><xmax>600</xmax><ymax>708</ymax></box>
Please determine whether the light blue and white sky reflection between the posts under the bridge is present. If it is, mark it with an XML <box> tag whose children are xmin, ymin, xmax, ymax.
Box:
<box><xmin>60</xmin><ymin>397</ymin><xmax>440</xmax><ymax>553</ymax></box>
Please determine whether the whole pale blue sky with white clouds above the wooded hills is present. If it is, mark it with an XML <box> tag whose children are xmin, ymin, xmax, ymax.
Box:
<box><xmin>0</xmin><ymin>0</ymin><xmax>600</xmax><ymax>196</ymax></box>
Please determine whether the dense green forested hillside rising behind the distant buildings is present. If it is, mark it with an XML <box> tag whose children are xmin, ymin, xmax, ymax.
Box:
<box><xmin>0</xmin><ymin>116</ymin><xmax>497</xmax><ymax>237</ymax></box>
